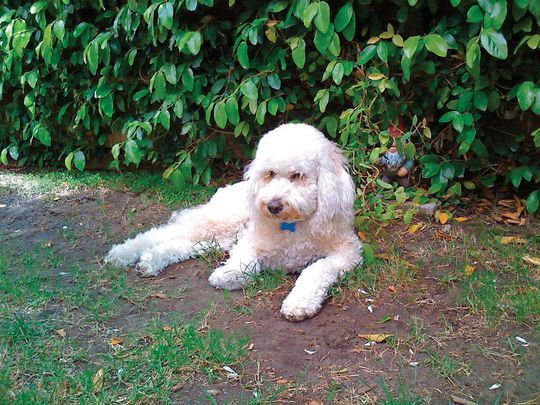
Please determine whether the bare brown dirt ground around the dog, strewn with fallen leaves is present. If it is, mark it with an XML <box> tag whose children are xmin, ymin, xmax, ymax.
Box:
<box><xmin>0</xmin><ymin>171</ymin><xmax>540</xmax><ymax>404</ymax></box>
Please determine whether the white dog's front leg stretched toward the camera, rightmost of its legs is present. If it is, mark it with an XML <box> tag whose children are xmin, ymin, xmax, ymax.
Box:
<box><xmin>281</xmin><ymin>251</ymin><xmax>361</xmax><ymax>321</ymax></box>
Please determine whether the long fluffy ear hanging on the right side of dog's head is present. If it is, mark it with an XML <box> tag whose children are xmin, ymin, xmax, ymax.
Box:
<box><xmin>310</xmin><ymin>141</ymin><xmax>355</xmax><ymax>238</ymax></box>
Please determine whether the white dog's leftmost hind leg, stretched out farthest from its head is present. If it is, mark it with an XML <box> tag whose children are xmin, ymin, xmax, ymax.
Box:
<box><xmin>105</xmin><ymin>224</ymin><xmax>186</xmax><ymax>267</ymax></box>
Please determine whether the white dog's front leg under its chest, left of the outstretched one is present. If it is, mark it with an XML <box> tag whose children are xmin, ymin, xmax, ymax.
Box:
<box><xmin>208</xmin><ymin>240</ymin><xmax>261</xmax><ymax>290</ymax></box>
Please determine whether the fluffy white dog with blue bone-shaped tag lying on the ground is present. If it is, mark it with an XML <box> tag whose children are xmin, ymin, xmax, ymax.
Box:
<box><xmin>106</xmin><ymin>124</ymin><xmax>362</xmax><ymax>321</ymax></box>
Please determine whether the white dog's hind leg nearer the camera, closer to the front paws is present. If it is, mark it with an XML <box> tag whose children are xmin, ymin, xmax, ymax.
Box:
<box><xmin>136</xmin><ymin>239</ymin><xmax>212</xmax><ymax>277</ymax></box>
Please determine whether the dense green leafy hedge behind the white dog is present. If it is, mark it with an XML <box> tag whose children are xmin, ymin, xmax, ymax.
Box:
<box><xmin>0</xmin><ymin>0</ymin><xmax>540</xmax><ymax>211</ymax></box>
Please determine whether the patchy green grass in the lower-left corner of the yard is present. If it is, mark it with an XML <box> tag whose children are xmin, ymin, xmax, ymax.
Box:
<box><xmin>0</xmin><ymin>241</ymin><xmax>247</xmax><ymax>404</ymax></box>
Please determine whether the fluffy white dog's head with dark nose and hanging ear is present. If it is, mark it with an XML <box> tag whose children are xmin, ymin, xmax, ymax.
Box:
<box><xmin>245</xmin><ymin>124</ymin><xmax>354</xmax><ymax>237</ymax></box>
